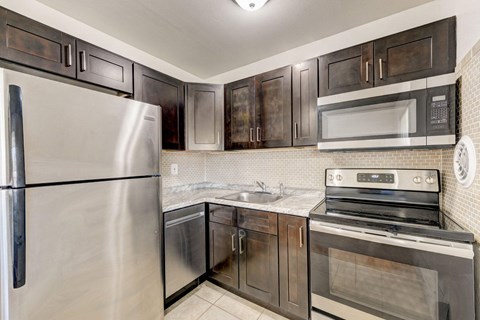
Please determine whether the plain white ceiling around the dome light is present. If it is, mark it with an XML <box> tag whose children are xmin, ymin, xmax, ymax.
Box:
<box><xmin>38</xmin><ymin>0</ymin><xmax>432</xmax><ymax>79</ymax></box>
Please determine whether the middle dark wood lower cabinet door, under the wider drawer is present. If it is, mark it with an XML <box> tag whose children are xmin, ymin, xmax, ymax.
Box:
<box><xmin>238</xmin><ymin>229</ymin><xmax>279</xmax><ymax>306</ymax></box>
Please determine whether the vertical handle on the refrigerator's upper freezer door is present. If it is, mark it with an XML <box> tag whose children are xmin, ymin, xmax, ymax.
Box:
<box><xmin>9</xmin><ymin>85</ymin><xmax>25</xmax><ymax>188</ymax></box>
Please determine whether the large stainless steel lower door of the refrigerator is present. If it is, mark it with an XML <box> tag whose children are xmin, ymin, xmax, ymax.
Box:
<box><xmin>0</xmin><ymin>178</ymin><xmax>163</xmax><ymax>320</ymax></box>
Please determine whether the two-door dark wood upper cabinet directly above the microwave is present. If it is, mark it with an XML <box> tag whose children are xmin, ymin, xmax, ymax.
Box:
<box><xmin>318</xmin><ymin>17</ymin><xmax>456</xmax><ymax>97</ymax></box>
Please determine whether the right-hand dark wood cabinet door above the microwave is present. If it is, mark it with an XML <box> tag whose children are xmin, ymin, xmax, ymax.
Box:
<box><xmin>375</xmin><ymin>17</ymin><xmax>456</xmax><ymax>86</ymax></box>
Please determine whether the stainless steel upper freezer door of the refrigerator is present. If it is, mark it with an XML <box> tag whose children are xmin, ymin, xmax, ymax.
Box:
<box><xmin>0</xmin><ymin>69</ymin><xmax>161</xmax><ymax>186</ymax></box>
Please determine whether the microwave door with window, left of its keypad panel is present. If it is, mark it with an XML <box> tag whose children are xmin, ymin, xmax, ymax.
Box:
<box><xmin>318</xmin><ymin>89</ymin><xmax>427</xmax><ymax>150</ymax></box>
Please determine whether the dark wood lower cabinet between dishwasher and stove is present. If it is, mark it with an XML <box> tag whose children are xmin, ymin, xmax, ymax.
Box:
<box><xmin>209</xmin><ymin>205</ymin><xmax>310</xmax><ymax>319</ymax></box>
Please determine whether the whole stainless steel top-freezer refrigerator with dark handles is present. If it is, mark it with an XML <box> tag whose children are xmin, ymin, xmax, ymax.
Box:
<box><xmin>0</xmin><ymin>69</ymin><xmax>163</xmax><ymax>320</ymax></box>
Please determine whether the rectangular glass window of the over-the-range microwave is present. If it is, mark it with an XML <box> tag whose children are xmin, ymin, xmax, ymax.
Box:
<box><xmin>321</xmin><ymin>99</ymin><xmax>417</xmax><ymax>139</ymax></box>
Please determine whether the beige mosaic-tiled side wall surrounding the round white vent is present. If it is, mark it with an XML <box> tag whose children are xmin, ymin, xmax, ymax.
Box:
<box><xmin>442</xmin><ymin>41</ymin><xmax>480</xmax><ymax>241</ymax></box>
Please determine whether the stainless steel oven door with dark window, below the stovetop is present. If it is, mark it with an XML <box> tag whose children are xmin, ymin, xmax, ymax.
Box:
<box><xmin>310</xmin><ymin>220</ymin><xmax>475</xmax><ymax>320</ymax></box>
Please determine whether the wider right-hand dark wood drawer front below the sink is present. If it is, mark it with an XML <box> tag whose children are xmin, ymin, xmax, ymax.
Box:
<box><xmin>237</xmin><ymin>208</ymin><xmax>277</xmax><ymax>235</ymax></box>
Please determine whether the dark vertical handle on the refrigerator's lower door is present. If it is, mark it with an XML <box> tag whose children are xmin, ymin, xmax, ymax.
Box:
<box><xmin>12</xmin><ymin>189</ymin><xmax>27</xmax><ymax>288</ymax></box>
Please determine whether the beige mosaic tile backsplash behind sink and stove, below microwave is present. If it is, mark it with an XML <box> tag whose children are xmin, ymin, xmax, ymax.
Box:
<box><xmin>206</xmin><ymin>148</ymin><xmax>441</xmax><ymax>190</ymax></box>
